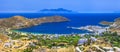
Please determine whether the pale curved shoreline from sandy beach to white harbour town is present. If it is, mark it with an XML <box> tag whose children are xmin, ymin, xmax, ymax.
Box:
<box><xmin>10</xmin><ymin>25</ymin><xmax>109</xmax><ymax>35</ymax></box>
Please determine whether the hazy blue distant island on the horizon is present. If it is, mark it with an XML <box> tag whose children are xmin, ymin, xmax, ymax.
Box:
<box><xmin>38</xmin><ymin>8</ymin><xmax>77</xmax><ymax>13</ymax></box>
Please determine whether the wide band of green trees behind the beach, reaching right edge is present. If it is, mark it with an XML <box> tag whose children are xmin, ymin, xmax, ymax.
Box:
<box><xmin>8</xmin><ymin>31</ymin><xmax>120</xmax><ymax>52</ymax></box>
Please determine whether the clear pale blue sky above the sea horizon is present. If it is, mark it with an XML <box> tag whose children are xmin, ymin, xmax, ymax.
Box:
<box><xmin>0</xmin><ymin>0</ymin><xmax>120</xmax><ymax>13</ymax></box>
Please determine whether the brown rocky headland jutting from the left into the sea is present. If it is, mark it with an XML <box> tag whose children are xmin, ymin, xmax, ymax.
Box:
<box><xmin>0</xmin><ymin>16</ymin><xmax>69</xmax><ymax>29</ymax></box>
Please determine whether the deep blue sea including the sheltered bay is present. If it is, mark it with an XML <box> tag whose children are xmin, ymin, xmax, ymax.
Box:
<box><xmin>0</xmin><ymin>13</ymin><xmax>120</xmax><ymax>34</ymax></box>
